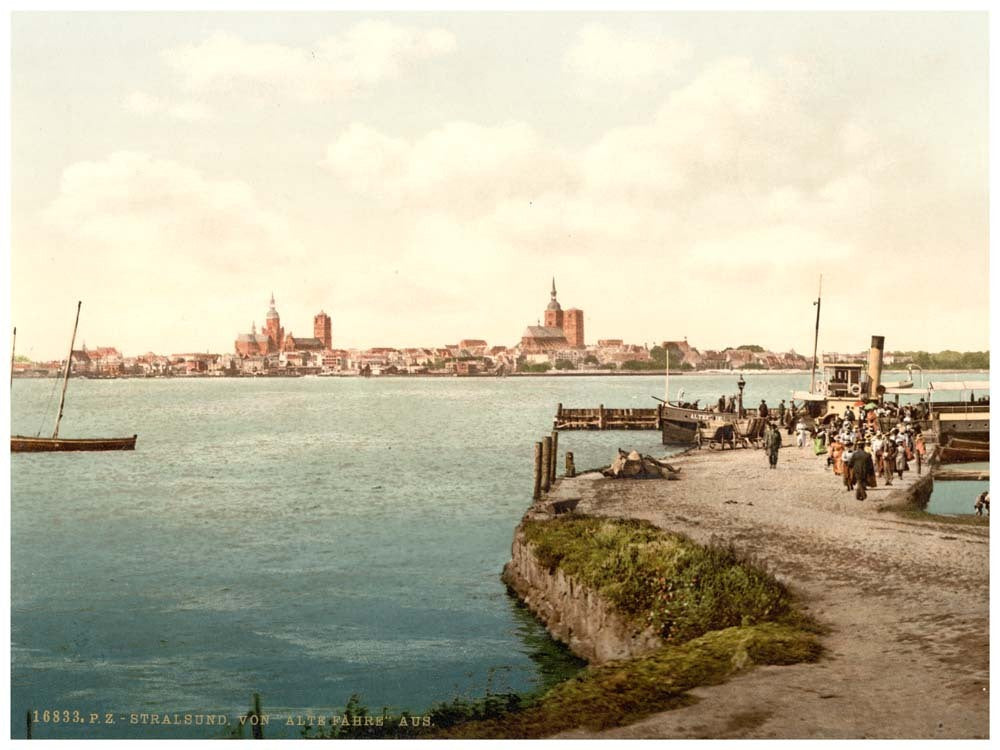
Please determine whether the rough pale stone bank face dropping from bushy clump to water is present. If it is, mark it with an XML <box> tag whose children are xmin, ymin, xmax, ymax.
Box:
<box><xmin>503</xmin><ymin>526</ymin><xmax>663</xmax><ymax>664</ymax></box>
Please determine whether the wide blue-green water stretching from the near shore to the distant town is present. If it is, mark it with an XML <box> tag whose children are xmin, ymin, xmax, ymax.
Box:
<box><xmin>11</xmin><ymin>374</ymin><xmax>984</xmax><ymax>738</ymax></box>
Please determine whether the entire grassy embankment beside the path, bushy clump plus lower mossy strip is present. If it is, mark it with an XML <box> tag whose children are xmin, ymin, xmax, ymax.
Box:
<box><xmin>302</xmin><ymin>516</ymin><xmax>821</xmax><ymax>738</ymax></box>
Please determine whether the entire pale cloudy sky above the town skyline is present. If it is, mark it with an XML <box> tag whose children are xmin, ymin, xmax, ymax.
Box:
<box><xmin>11</xmin><ymin>13</ymin><xmax>988</xmax><ymax>358</ymax></box>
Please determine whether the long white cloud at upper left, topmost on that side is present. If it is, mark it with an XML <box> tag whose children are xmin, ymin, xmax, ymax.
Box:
<box><xmin>164</xmin><ymin>21</ymin><xmax>457</xmax><ymax>102</ymax></box>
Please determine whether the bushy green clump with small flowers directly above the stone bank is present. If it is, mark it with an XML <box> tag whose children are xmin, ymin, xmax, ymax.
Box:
<box><xmin>523</xmin><ymin>516</ymin><xmax>812</xmax><ymax>642</ymax></box>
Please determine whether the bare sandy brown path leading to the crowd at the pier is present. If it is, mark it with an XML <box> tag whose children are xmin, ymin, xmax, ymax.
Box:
<box><xmin>549</xmin><ymin>440</ymin><xmax>989</xmax><ymax>738</ymax></box>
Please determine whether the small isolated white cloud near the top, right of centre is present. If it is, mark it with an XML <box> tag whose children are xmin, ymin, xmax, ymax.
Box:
<box><xmin>563</xmin><ymin>23</ymin><xmax>692</xmax><ymax>90</ymax></box>
